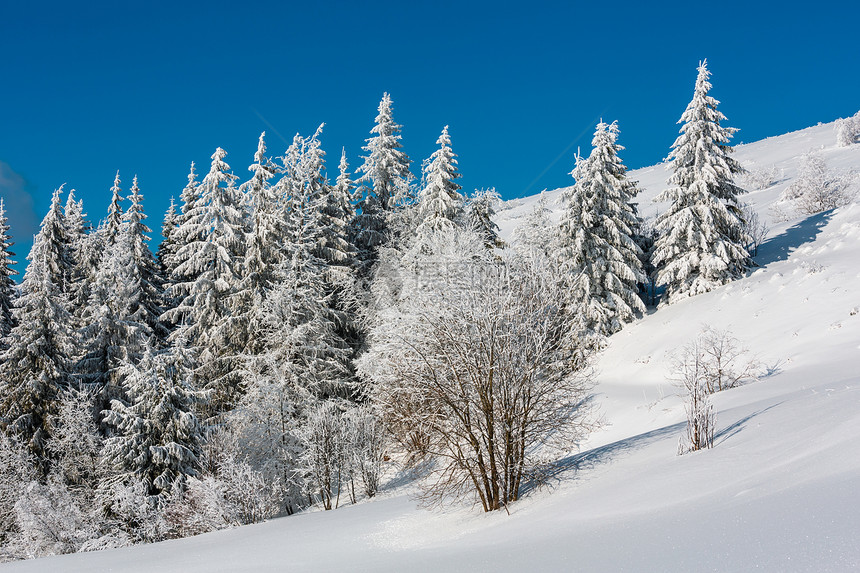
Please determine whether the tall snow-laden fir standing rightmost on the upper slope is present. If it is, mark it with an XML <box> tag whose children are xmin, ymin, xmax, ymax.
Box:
<box><xmin>651</xmin><ymin>60</ymin><xmax>752</xmax><ymax>303</ymax></box>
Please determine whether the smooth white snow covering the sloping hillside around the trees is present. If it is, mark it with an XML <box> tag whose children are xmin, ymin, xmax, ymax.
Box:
<box><xmin>0</xmin><ymin>119</ymin><xmax>860</xmax><ymax>573</ymax></box>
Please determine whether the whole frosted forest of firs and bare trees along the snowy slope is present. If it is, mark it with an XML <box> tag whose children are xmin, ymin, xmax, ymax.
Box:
<box><xmin>0</xmin><ymin>63</ymin><xmax>751</xmax><ymax>559</ymax></box>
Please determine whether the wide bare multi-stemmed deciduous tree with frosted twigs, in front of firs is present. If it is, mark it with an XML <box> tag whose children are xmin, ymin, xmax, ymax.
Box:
<box><xmin>358</xmin><ymin>227</ymin><xmax>588</xmax><ymax>511</ymax></box>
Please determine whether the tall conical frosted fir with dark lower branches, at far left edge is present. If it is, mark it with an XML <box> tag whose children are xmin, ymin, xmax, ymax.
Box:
<box><xmin>0</xmin><ymin>187</ymin><xmax>74</xmax><ymax>475</ymax></box>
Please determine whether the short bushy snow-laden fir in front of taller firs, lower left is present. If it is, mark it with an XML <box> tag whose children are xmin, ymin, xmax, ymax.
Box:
<box><xmin>100</xmin><ymin>340</ymin><xmax>204</xmax><ymax>498</ymax></box>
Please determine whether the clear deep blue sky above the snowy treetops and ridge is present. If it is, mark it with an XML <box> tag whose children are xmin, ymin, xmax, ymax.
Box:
<box><xmin>0</xmin><ymin>0</ymin><xmax>860</xmax><ymax>274</ymax></box>
